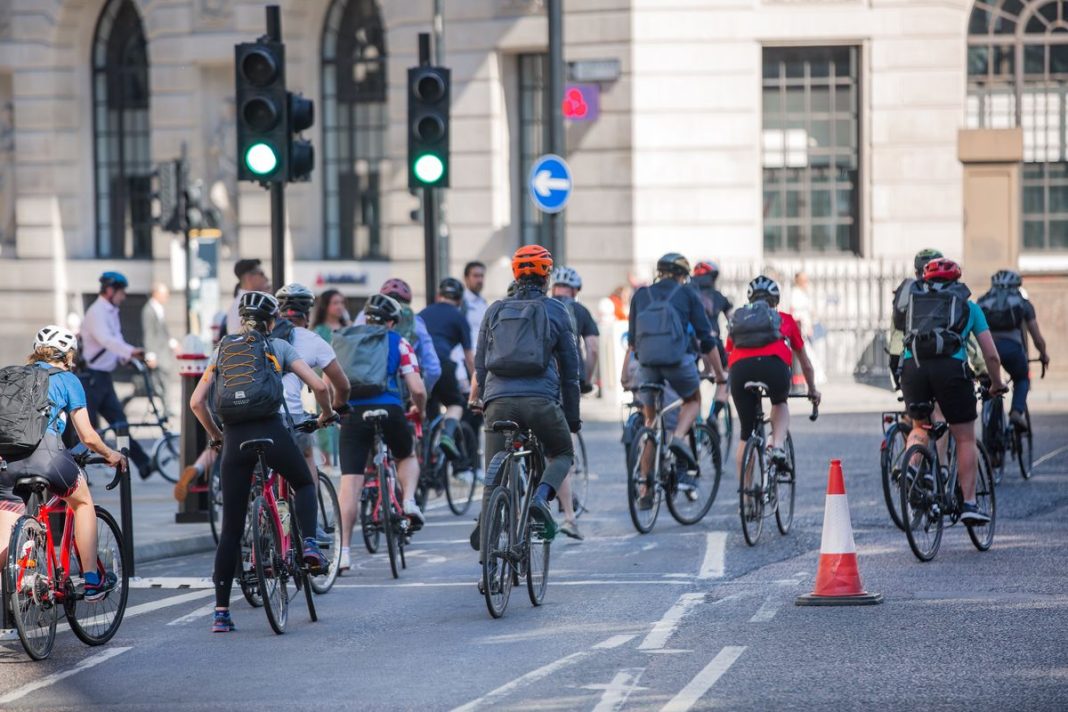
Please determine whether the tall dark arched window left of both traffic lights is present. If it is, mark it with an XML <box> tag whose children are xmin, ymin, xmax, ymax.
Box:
<box><xmin>92</xmin><ymin>0</ymin><xmax>152</xmax><ymax>258</ymax></box>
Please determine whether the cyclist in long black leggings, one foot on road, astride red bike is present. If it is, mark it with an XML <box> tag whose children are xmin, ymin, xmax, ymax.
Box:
<box><xmin>189</xmin><ymin>291</ymin><xmax>333</xmax><ymax>633</ymax></box>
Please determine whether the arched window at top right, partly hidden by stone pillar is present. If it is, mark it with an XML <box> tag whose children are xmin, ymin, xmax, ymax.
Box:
<box><xmin>967</xmin><ymin>0</ymin><xmax>1068</xmax><ymax>251</ymax></box>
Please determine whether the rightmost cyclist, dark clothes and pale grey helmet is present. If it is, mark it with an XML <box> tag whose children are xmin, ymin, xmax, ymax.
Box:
<box><xmin>978</xmin><ymin>269</ymin><xmax>1050</xmax><ymax>429</ymax></box>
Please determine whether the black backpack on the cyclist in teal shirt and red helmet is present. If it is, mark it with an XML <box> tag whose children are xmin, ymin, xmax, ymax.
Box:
<box><xmin>905</xmin><ymin>282</ymin><xmax>971</xmax><ymax>361</ymax></box>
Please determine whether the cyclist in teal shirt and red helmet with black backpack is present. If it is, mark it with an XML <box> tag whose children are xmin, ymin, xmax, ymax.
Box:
<box><xmin>901</xmin><ymin>257</ymin><xmax>1006</xmax><ymax>526</ymax></box>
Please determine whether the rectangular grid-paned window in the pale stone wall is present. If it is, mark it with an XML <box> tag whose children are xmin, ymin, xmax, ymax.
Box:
<box><xmin>764</xmin><ymin>47</ymin><xmax>860</xmax><ymax>253</ymax></box>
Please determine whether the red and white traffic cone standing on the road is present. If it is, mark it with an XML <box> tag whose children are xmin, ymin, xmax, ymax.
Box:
<box><xmin>796</xmin><ymin>460</ymin><xmax>882</xmax><ymax>605</ymax></box>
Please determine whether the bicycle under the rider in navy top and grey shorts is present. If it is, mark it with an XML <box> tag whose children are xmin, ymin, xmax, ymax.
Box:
<box><xmin>627</xmin><ymin>383</ymin><xmax>723</xmax><ymax>534</ymax></box>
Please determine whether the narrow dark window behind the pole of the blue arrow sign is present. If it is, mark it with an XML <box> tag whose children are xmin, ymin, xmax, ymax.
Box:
<box><xmin>515</xmin><ymin>53</ymin><xmax>552</xmax><ymax>244</ymax></box>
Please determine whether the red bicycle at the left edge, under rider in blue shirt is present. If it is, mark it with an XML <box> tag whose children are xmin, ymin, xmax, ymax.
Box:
<box><xmin>0</xmin><ymin>450</ymin><xmax>131</xmax><ymax>660</ymax></box>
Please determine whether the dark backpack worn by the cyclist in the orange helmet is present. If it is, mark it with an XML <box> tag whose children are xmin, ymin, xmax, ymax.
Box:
<box><xmin>486</xmin><ymin>296</ymin><xmax>552</xmax><ymax>378</ymax></box>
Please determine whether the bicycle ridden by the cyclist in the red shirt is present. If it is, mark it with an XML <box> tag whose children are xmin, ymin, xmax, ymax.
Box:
<box><xmin>738</xmin><ymin>381</ymin><xmax>819</xmax><ymax>547</ymax></box>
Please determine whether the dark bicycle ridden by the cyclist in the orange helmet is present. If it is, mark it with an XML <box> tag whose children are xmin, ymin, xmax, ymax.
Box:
<box><xmin>478</xmin><ymin>421</ymin><xmax>552</xmax><ymax>618</ymax></box>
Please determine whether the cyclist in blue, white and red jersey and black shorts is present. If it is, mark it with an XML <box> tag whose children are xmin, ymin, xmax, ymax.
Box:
<box><xmin>334</xmin><ymin>295</ymin><xmax>426</xmax><ymax>571</ymax></box>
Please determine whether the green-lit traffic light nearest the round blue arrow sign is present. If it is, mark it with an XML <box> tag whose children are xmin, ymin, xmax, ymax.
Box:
<box><xmin>408</xmin><ymin>66</ymin><xmax>451</xmax><ymax>188</ymax></box>
